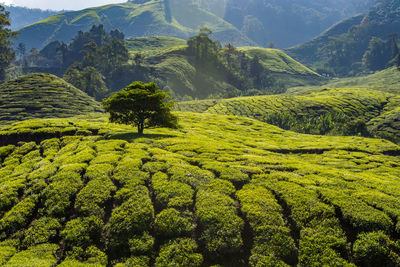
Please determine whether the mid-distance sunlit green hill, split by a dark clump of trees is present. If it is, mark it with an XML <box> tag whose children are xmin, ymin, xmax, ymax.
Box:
<box><xmin>138</xmin><ymin>45</ymin><xmax>324</xmax><ymax>98</ymax></box>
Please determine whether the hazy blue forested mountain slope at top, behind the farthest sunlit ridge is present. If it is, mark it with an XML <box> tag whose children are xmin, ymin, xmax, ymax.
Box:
<box><xmin>192</xmin><ymin>0</ymin><xmax>377</xmax><ymax>48</ymax></box>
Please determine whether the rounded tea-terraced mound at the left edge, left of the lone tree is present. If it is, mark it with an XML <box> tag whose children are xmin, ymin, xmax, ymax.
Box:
<box><xmin>0</xmin><ymin>73</ymin><xmax>102</xmax><ymax>124</ymax></box>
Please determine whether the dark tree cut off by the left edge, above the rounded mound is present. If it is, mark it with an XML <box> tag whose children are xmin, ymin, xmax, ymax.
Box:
<box><xmin>0</xmin><ymin>5</ymin><xmax>17</xmax><ymax>83</ymax></box>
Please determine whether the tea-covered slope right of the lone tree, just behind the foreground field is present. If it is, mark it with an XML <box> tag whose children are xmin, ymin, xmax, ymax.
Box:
<box><xmin>176</xmin><ymin>87</ymin><xmax>400</xmax><ymax>142</ymax></box>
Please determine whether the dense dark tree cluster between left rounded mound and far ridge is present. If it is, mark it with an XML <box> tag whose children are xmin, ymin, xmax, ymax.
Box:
<box><xmin>13</xmin><ymin>25</ymin><xmax>133</xmax><ymax>100</ymax></box>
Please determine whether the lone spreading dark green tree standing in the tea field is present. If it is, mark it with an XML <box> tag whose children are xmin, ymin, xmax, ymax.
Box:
<box><xmin>102</xmin><ymin>82</ymin><xmax>178</xmax><ymax>134</ymax></box>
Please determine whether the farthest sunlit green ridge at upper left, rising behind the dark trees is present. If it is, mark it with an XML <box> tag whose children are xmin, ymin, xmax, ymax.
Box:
<box><xmin>16</xmin><ymin>0</ymin><xmax>253</xmax><ymax>49</ymax></box>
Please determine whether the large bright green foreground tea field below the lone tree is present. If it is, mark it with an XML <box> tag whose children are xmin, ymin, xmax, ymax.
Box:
<box><xmin>0</xmin><ymin>112</ymin><xmax>400</xmax><ymax>266</ymax></box>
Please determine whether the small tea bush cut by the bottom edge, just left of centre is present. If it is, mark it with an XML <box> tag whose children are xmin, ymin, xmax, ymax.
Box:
<box><xmin>155</xmin><ymin>238</ymin><xmax>203</xmax><ymax>267</ymax></box>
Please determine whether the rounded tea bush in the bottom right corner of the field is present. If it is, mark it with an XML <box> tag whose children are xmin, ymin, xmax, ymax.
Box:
<box><xmin>353</xmin><ymin>232</ymin><xmax>400</xmax><ymax>267</ymax></box>
